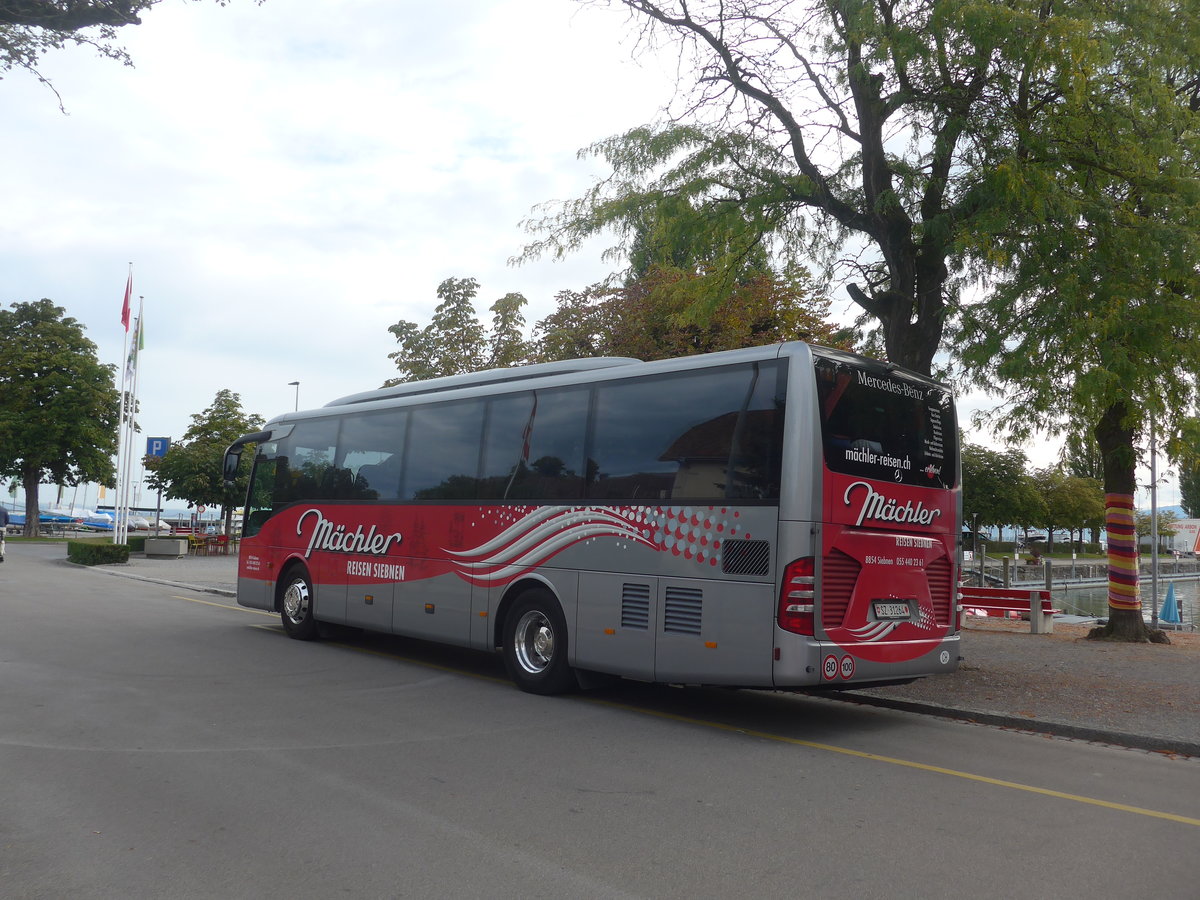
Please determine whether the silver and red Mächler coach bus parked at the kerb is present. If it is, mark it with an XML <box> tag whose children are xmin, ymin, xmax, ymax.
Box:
<box><xmin>226</xmin><ymin>342</ymin><xmax>961</xmax><ymax>694</ymax></box>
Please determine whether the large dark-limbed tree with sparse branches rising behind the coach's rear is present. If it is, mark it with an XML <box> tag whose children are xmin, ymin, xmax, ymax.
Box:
<box><xmin>526</xmin><ymin>0</ymin><xmax>1113</xmax><ymax>374</ymax></box>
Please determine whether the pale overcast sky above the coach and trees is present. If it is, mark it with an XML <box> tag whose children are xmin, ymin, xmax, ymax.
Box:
<box><xmin>0</xmin><ymin>0</ymin><xmax>1174</xmax><ymax>505</ymax></box>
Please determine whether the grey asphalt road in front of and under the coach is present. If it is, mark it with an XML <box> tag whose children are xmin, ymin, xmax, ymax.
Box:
<box><xmin>0</xmin><ymin>542</ymin><xmax>1200</xmax><ymax>900</ymax></box>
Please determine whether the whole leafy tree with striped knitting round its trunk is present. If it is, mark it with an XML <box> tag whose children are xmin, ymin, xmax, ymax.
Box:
<box><xmin>960</xmin><ymin>0</ymin><xmax>1200</xmax><ymax>641</ymax></box>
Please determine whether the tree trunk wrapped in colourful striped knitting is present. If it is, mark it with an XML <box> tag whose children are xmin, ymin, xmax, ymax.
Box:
<box><xmin>1088</xmin><ymin>401</ymin><xmax>1165</xmax><ymax>642</ymax></box>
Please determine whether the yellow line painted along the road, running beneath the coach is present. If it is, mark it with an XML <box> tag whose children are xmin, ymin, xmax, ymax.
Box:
<box><xmin>174</xmin><ymin>594</ymin><xmax>1200</xmax><ymax>828</ymax></box>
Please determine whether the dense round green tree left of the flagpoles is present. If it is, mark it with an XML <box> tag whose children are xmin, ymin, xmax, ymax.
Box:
<box><xmin>0</xmin><ymin>300</ymin><xmax>121</xmax><ymax>535</ymax></box>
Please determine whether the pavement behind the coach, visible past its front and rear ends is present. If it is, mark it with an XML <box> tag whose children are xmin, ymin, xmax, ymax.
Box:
<box><xmin>96</xmin><ymin>556</ymin><xmax>1200</xmax><ymax>757</ymax></box>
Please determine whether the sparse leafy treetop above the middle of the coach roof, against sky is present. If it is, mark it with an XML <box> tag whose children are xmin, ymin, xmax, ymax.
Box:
<box><xmin>384</xmin><ymin>278</ymin><xmax>528</xmax><ymax>386</ymax></box>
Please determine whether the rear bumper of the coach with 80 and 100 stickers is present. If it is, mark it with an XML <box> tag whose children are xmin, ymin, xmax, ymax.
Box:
<box><xmin>773</xmin><ymin>631</ymin><xmax>960</xmax><ymax>690</ymax></box>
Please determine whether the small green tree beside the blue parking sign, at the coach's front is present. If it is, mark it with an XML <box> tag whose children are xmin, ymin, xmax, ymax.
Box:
<box><xmin>144</xmin><ymin>389</ymin><xmax>265</xmax><ymax>534</ymax></box>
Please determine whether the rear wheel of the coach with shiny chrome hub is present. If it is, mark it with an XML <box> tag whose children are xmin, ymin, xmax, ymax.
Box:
<box><xmin>504</xmin><ymin>589</ymin><xmax>575</xmax><ymax>694</ymax></box>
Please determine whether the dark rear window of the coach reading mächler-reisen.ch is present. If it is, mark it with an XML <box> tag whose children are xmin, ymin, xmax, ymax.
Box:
<box><xmin>816</xmin><ymin>359</ymin><xmax>958</xmax><ymax>487</ymax></box>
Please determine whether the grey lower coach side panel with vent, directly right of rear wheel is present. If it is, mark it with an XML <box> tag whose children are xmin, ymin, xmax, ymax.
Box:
<box><xmin>571</xmin><ymin>572</ymin><xmax>659</xmax><ymax>682</ymax></box>
